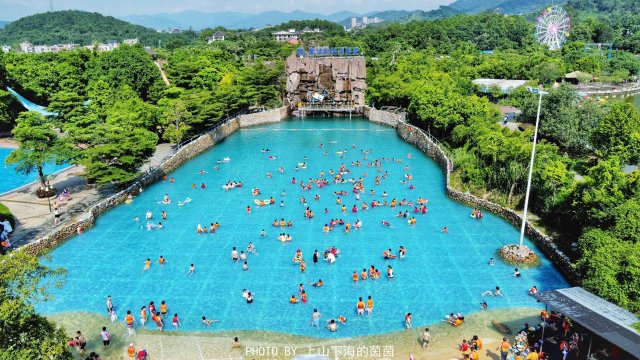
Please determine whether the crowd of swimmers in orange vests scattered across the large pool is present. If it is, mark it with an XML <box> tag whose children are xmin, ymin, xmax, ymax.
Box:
<box><xmin>111</xmin><ymin>138</ymin><xmax>552</xmax><ymax>344</ymax></box>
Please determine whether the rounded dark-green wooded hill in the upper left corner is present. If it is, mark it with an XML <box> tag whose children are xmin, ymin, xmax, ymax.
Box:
<box><xmin>0</xmin><ymin>10</ymin><xmax>158</xmax><ymax>45</ymax></box>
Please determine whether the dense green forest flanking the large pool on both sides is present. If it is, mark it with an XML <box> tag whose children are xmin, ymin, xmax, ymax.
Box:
<box><xmin>0</xmin><ymin>4</ymin><xmax>640</xmax><ymax>356</ymax></box>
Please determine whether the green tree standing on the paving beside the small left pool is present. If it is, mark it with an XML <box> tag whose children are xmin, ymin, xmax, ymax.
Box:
<box><xmin>5</xmin><ymin>111</ymin><xmax>65</xmax><ymax>188</ymax></box>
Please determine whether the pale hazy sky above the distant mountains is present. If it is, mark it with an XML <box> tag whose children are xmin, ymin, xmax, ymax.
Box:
<box><xmin>0</xmin><ymin>0</ymin><xmax>454</xmax><ymax>20</ymax></box>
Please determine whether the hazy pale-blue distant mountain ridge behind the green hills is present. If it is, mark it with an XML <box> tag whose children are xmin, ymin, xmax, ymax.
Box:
<box><xmin>122</xmin><ymin>10</ymin><xmax>360</xmax><ymax>30</ymax></box>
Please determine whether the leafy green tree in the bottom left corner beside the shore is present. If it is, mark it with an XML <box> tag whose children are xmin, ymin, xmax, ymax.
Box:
<box><xmin>0</xmin><ymin>251</ymin><xmax>73</xmax><ymax>360</ymax></box>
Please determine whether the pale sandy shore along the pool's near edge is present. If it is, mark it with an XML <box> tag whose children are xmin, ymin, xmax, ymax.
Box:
<box><xmin>48</xmin><ymin>308</ymin><xmax>539</xmax><ymax>360</ymax></box>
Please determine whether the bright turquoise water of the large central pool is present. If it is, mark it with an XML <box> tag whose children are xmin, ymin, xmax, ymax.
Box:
<box><xmin>38</xmin><ymin>119</ymin><xmax>567</xmax><ymax>337</ymax></box>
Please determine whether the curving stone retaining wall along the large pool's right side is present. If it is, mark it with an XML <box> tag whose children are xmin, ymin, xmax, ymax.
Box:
<box><xmin>365</xmin><ymin>109</ymin><xmax>578</xmax><ymax>284</ymax></box>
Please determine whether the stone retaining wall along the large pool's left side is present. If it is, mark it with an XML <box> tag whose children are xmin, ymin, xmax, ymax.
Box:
<box><xmin>22</xmin><ymin>107</ymin><xmax>287</xmax><ymax>255</ymax></box>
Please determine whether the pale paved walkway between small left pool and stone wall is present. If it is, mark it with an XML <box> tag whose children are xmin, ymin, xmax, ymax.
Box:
<box><xmin>0</xmin><ymin>144</ymin><xmax>174</xmax><ymax>248</ymax></box>
